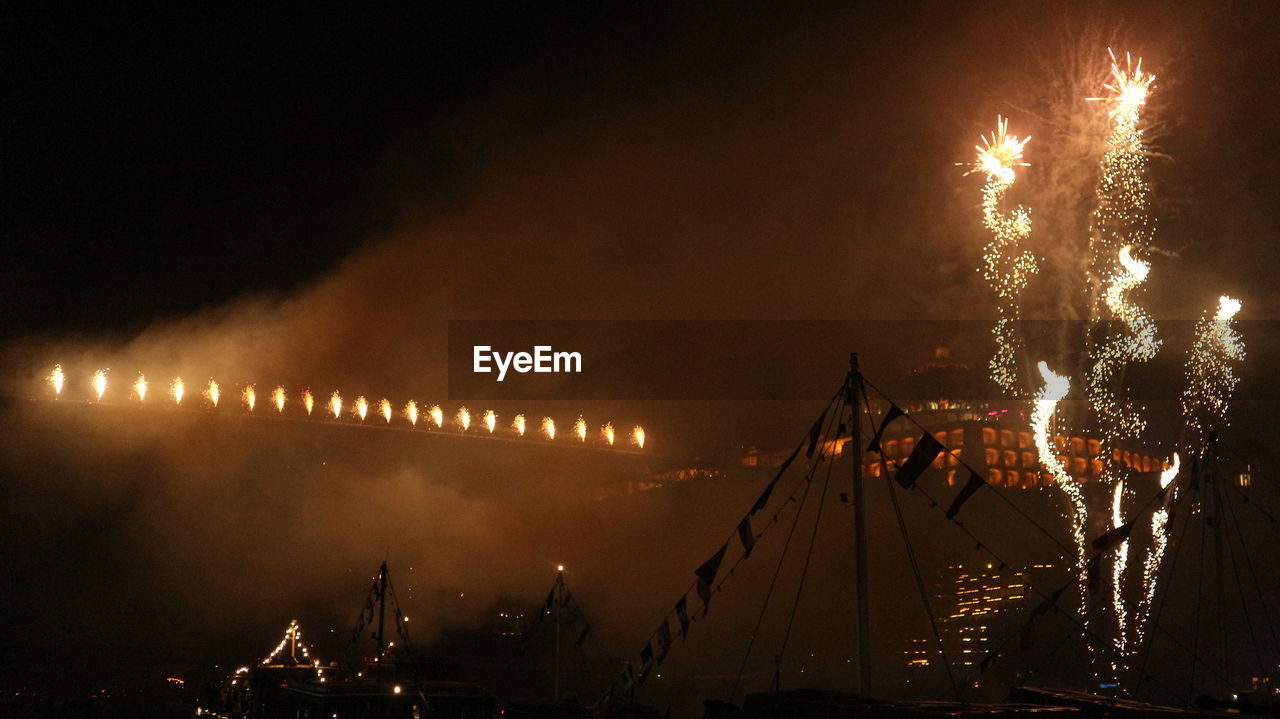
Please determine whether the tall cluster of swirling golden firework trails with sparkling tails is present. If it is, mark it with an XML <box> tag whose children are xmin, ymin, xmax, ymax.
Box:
<box><xmin>972</xmin><ymin>47</ymin><xmax>1244</xmax><ymax>676</ymax></box>
